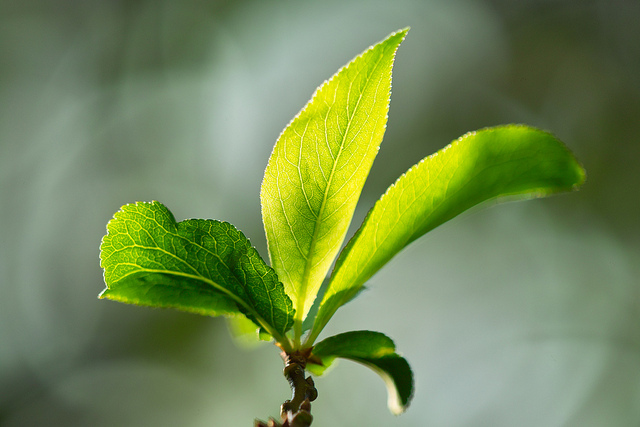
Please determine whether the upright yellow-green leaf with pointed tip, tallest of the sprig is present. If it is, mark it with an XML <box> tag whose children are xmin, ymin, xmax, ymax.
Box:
<box><xmin>260</xmin><ymin>29</ymin><xmax>408</xmax><ymax>328</ymax></box>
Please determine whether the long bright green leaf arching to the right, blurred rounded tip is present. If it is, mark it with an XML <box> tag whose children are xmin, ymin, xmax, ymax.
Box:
<box><xmin>309</xmin><ymin>125</ymin><xmax>585</xmax><ymax>342</ymax></box>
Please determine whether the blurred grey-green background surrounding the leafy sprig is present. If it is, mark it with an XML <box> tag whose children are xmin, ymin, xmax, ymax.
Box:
<box><xmin>0</xmin><ymin>0</ymin><xmax>640</xmax><ymax>427</ymax></box>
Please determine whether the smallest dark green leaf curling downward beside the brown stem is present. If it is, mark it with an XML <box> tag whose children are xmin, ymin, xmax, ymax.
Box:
<box><xmin>307</xmin><ymin>331</ymin><xmax>413</xmax><ymax>415</ymax></box>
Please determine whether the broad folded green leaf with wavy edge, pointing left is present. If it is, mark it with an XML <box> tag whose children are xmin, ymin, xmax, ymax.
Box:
<box><xmin>100</xmin><ymin>202</ymin><xmax>294</xmax><ymax>341</ymax></box>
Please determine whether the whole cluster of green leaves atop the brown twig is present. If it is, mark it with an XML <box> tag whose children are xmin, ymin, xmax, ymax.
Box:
<box><xmin>100</xmin><ymin>29</ymin><xmax>585</xmax><ymax>420</ymax></box>
